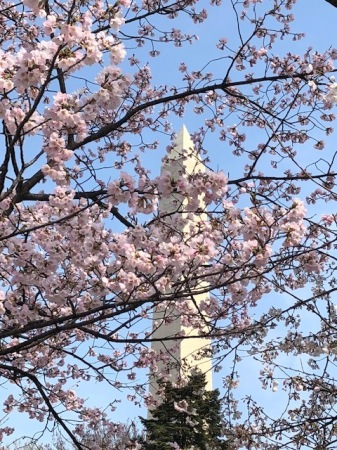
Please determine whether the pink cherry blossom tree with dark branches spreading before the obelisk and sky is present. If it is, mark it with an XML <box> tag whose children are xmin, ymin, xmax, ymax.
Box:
<box><xmin>0</xmin><ymin>0</ymin><xmax>337</xmax><ymax>450</ymax></box>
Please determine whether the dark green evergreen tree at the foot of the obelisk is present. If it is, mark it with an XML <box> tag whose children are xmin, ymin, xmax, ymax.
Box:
<box><xmin>140</xmin><ymin>372</ymin><xmax>228</xmax><ymax>450</ymax></box>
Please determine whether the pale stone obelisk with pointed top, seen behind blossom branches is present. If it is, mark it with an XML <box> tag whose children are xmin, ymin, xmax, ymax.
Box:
<box><xmin>150</xmin><ymin>126</ymin><xmax>212</xmax><ymax>404</ymax></box>
